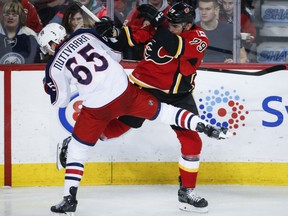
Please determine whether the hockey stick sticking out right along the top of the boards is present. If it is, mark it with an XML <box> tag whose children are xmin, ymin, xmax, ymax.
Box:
<box><xmin>198</xmin><ymin>65</ymin><xmax>287</xmax><ymax>76</ymax></box>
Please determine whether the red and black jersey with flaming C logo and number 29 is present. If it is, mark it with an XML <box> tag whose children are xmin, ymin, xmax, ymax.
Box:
<box><xmin>129</xmin><ymin>25</ymin><xmax>208</xmax><ymax>94</ymax></box>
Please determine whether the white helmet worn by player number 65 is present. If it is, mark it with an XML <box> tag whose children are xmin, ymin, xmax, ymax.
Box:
<box><xmin>38</xmin><ymin>23</ymin><xmax>67</xmax><ymax>55</ymax></box>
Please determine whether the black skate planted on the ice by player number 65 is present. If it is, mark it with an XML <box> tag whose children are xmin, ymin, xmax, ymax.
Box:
<box><xmin>51</xmin><ymin>187</ymin><xmax>78</xmax><ymax>216</ymax></box>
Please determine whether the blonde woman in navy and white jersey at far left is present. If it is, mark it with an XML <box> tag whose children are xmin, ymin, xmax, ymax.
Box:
<box><xmin>0</xmin><ymin>0</ymin><xmax>40</xmax><ymax>64</ymax></box>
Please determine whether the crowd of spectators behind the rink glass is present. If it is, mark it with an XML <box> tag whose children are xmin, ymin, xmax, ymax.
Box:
<box><xmin>0</xmin><ymin>0</ymin><xmax>257</xmax><ymax>64</ymax></box>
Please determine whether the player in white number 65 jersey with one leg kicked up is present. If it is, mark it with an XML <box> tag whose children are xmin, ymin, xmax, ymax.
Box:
<box><xmin>38</xmin><ymin>19</ymin><xmax>231</xmax><ymax>215</ymax></box>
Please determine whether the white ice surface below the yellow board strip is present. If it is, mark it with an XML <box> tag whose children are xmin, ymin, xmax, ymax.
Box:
<box><xmin>0</xmin><ymin>185</ymin><xmax>288</xmax><ymax>216</ymax></box>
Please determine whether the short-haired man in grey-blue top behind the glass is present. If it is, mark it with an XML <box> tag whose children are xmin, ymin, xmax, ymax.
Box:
<box><xmin>197</xmin><ymin>0</ymin><xmax>247</xmax><ymax>63</ymax></box>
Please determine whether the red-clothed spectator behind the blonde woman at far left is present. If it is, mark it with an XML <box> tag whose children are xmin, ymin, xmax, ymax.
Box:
<box><xmin>0</xmin><ymin>0</ymin><xmax>43</xmax><ymax>33</ymax></box>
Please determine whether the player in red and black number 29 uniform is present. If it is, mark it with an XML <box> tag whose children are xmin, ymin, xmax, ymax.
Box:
<box><xmin>103</xmin><ymin>2</ymin><xmax>212</xmax><ymax>212</ymax></box>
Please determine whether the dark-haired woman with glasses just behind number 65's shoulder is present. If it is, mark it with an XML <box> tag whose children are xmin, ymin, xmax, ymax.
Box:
<box><xmin>62</xmin><ymin>2</ymin><xmax>94</xmax><ymax>34</ymax></box>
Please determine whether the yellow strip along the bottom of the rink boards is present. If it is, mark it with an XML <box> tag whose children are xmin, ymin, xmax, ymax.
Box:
<box><xmin>0</xmin><ymin>162</ymin><xmax>288</xmax><ymax>186</ymax></box>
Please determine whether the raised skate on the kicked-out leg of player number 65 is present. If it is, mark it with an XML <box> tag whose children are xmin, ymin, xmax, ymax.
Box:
<box><xmin>196</xmin><ymin>122</ymin><xmax>233</xmax><ymax>140</ymax></box>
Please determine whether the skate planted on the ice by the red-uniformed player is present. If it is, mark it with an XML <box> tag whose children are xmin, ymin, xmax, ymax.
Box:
<box><xmin>178</xmin><ymin>187</ymin><xmax>208</xmax><ymax>213</ymax></box>
